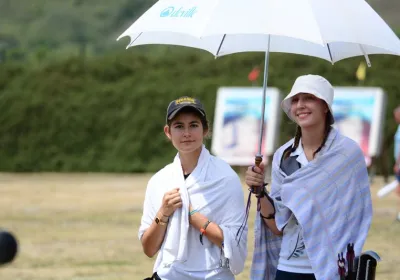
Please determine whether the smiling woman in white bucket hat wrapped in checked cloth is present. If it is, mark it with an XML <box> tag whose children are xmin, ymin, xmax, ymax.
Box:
<box><xmin>246</xmin><ymin>75</ymin><xmax>372</xmax><ymax>280</ymax></box>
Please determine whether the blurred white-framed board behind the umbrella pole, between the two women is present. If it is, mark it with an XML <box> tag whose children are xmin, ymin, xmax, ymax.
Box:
<box><xmin>211</xmin><ymin>87</ymin><xmax>281</xmax><ymax>166</ymax></box>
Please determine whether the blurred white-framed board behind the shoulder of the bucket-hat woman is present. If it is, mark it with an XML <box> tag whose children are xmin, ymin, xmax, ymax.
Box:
<box><xmin>332</xmin><ymin>87</ymin><xmax>386</xmax><ymax>166</ymax></box>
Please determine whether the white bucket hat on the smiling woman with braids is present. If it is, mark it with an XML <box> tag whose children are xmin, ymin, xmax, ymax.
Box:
<box><xmin>281</xmin><ymin>75</ymin><xmax>335</xmax><ymax>124</ymax></box>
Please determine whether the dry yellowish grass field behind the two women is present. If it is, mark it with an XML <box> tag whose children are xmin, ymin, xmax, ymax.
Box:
<box><xmin>0</xmin><ymin>174</ymin><xmax>400</xmax><ymax>280</ymax></box>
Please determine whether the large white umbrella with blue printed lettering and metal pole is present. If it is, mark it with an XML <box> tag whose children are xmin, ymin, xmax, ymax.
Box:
<box><xmin>117</xmin><ymin>0</ymin><xmax>400</xmax><ymax>164</ymax></box>
